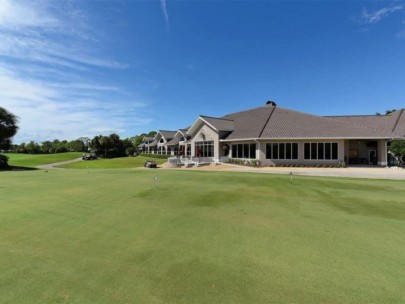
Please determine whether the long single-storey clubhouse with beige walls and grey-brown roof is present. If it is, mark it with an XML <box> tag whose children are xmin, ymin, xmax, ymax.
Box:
<box><xmin>138</xmin><ymin>101</ymin><xmax>405</xmax><ymax>166</ymax></box>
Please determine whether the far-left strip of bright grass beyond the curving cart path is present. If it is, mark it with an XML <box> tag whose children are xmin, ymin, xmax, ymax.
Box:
<box><xmin>3</xmin><ymin>152</ymin><xmax>83</xmax><ymax>168</ymax></box>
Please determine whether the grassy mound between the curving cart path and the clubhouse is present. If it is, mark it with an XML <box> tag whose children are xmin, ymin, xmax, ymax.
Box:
<box><xmin>59</xmin><ymin>156</ymin><xmax>167</xmax><ymax>169</ymax></box>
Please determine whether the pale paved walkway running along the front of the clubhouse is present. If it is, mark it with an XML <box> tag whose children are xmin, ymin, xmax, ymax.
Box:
<box><xmin>163</xmin><ymin>164</ymin><xmax>405</xmax><ymax>180</ymax></box>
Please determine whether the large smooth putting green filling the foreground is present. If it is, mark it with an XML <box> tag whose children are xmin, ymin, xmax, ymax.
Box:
<box><xmin>0</xmin><ymin>169</ymin><xmax>405</xmax><ymax>304</ymax></box>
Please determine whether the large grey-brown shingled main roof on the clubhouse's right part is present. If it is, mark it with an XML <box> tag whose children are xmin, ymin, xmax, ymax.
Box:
<box><xmin>221</xmin><ymin>105</ymin><xmax>405</xmax><ymax>140</ymax></box>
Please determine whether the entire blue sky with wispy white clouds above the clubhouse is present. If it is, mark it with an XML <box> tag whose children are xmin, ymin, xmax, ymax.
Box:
<box><xmin>0</xmin><ymin>0</ymin><xmax>405</xmax><ymax>143</ymax></box>
